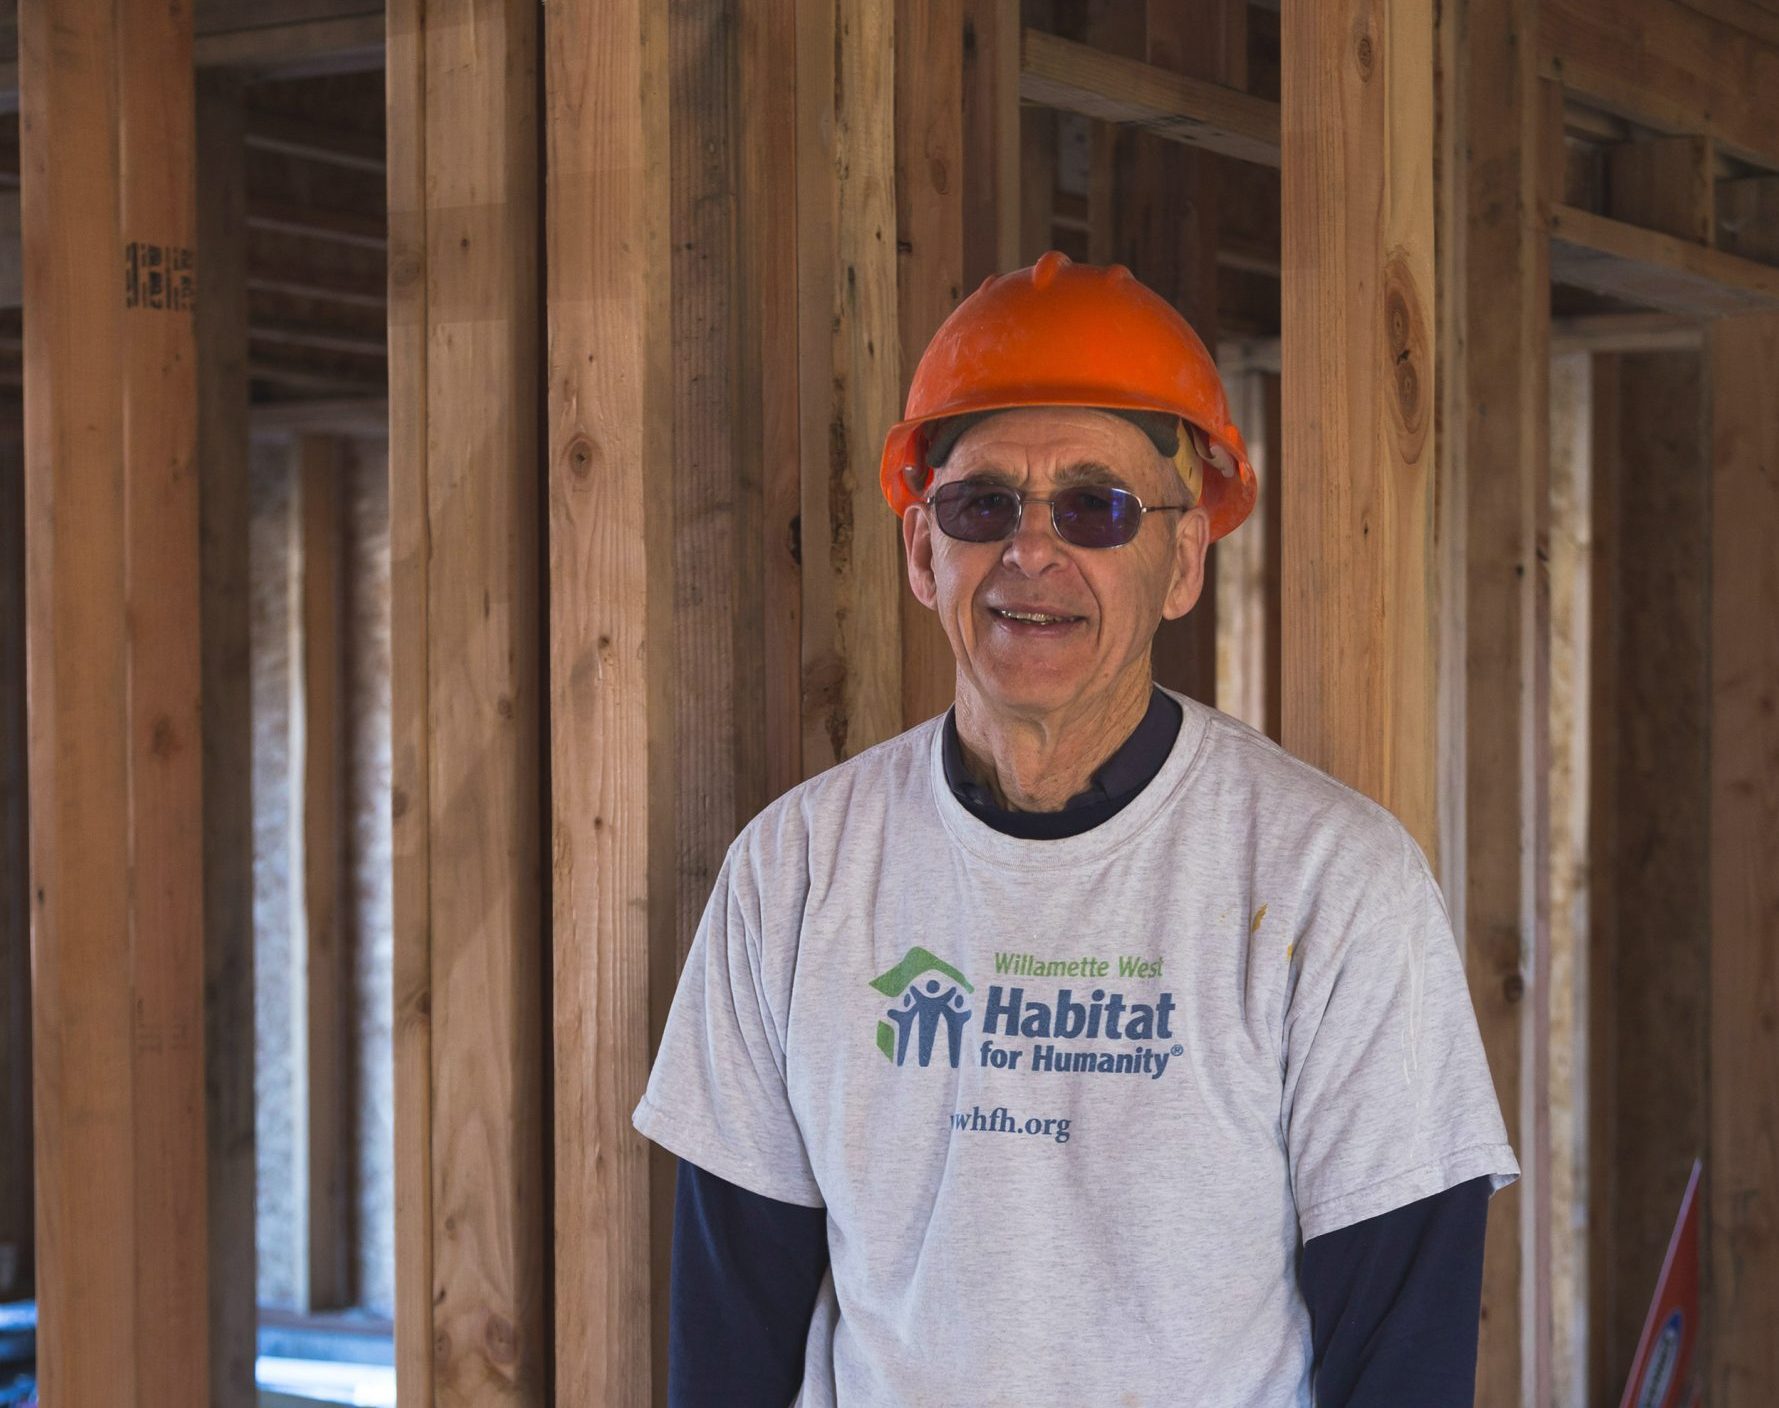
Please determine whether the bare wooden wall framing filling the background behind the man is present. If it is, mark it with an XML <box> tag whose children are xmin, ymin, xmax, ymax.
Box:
<box><xmin>0</xmin><ymin>0</ymin><xmax>1779</xmax><ymax>1408</ymax></box>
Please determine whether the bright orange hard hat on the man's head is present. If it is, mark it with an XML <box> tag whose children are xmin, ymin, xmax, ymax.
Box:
<box><xmin>881</xmin><ymin>249</ymin><xmax>1260</xmax><ymax>539</ymax></box>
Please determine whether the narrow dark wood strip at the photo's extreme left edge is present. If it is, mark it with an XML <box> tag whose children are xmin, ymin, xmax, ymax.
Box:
<box><xmin>0</xmin><ymin>425</ymin><xmax>36</xmax><ymax>1299</ymax></box>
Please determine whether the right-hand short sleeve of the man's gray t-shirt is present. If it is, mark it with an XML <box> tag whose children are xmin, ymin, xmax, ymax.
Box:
<box><xmin>1283</xmin><ymin>833</ymin><xmax>1519</xmax><ymax>1241</ymax></box>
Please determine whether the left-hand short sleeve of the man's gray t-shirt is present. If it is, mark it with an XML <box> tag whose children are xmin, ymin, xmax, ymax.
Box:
<box><xmin>632</xmin><ymin>842</ymin><xmax>822</xmax><ymax>1207</ymax></box>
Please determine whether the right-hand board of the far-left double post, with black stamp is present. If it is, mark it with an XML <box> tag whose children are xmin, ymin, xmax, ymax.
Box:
<box><xmin>116</xmin><ymin>5</ymin><xmax>210</xmax><ymax>1403</ymax></box>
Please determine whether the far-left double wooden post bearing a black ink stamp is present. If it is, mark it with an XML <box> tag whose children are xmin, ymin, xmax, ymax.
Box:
<box><xmin>20</xmin><ymin>0</ymin><xmax>210</xmax><ymax>1408</ymax></box>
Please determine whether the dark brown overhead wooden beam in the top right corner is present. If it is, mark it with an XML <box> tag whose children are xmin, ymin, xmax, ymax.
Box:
<box><xmin>1535</xmin><ymin>0</ymin><xmax>1779</xmax><ymax>171</ymax></box>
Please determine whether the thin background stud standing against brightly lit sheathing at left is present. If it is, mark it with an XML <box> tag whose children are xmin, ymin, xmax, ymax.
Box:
<box><xmin>294</xmin><ymin>434</ymin><xmax>352</xmax><ymax>1312</ymax></box>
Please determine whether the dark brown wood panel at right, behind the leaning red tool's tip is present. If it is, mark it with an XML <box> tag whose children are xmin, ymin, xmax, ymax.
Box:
<box><xmin>1589</xmin><ymin>352</ymin><xmax>1715</xmax><ymax>1401</ymax></box>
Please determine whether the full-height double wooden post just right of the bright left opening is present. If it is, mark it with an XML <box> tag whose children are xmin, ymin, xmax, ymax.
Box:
<box><xmin>388</xmin><ymin>0</ymin><xmax>544</xmax><ymax>1404</ymax></box>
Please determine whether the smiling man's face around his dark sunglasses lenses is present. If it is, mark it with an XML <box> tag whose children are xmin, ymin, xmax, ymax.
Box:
<box><xmin>902</xmin><ymin>406</ymin><xmax>1210</xmax><ymax>716</ymax></box>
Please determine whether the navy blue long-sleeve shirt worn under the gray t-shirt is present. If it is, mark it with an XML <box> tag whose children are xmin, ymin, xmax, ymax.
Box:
<box><xmin>667</xmin><ymin>689</ymin><xmax>1491</xmax><ymax>1408</ymax></box>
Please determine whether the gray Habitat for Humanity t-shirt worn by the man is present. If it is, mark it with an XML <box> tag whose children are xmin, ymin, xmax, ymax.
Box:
<box><xmin>635</xmin><ymin>696</ymin><xmax>1519</xmax><ymax>1408</ymax></box>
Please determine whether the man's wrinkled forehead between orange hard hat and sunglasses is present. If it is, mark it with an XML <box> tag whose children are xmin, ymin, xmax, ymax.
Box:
<box><xmin>932</xmin><ymin>406</ymin><xmax>1174</xmax><ymax>495</ymax></box>
